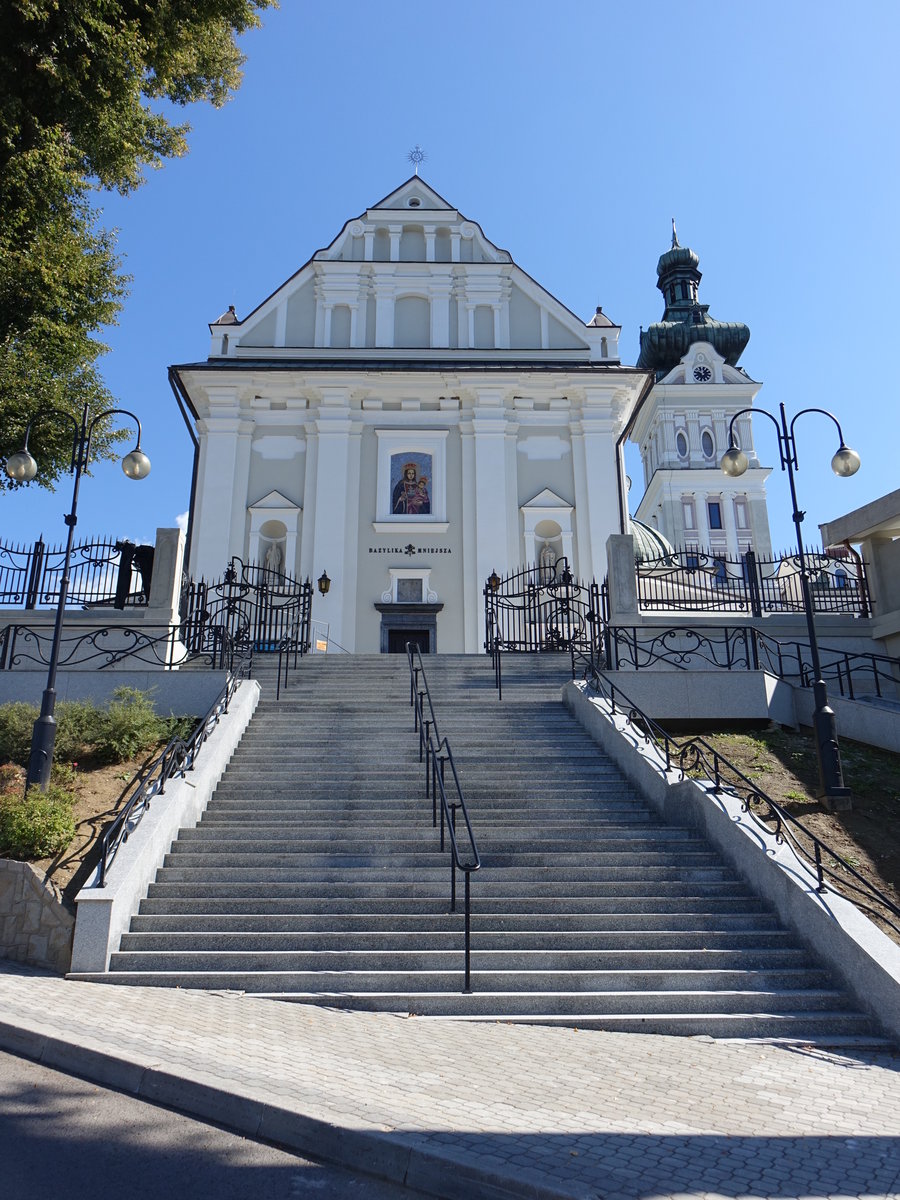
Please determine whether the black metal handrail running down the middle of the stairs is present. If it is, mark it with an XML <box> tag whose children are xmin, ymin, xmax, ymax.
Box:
<box><xmin>407</xmin><ymin>642</ymin><xmax>481</xmax><ymax>995</ymax></box>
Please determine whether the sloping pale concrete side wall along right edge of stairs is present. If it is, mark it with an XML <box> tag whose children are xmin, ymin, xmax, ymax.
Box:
<box><xmin>563</xmin><ymin>683</ymin><xmax>900</xmax><ymax>1038</ymax></box>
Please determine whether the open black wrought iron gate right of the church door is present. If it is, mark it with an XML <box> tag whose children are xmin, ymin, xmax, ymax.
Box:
<box><xmin>484</xmin><ymin>557</ymin><xmax>604</xmax><ymax>659</ymax></box>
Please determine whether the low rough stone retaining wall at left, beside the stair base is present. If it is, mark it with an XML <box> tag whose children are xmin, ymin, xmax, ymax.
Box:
<box><xmin>0</xmin><ymin>858</ymin><xmax>74</xmax><ymax>974</ymax></box>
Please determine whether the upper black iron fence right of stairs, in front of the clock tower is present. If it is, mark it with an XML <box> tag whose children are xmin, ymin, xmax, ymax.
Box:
<box><xmin>636</xmin><ymin>550</ymin><xmax>871</xmax><ymax>617</ymax></box>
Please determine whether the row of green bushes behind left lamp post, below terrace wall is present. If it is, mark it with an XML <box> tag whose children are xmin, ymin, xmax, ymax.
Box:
<box><xmin>0</xmin><ymin>688</ymin><xmax>197</xmax><ymax>770</ymax></box>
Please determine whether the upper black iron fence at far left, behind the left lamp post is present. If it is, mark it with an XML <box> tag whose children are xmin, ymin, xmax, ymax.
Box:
<box><xmin>0</xmin><ymin>538</ymin><xmax>154</xmax><ymax>608</ymax></box>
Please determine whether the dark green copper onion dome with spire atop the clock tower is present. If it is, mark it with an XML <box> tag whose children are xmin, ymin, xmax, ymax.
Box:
<box><xmin>637</xmin><ymin>221</ymin><xmax>750</xmax><ymax>378</ymax></box>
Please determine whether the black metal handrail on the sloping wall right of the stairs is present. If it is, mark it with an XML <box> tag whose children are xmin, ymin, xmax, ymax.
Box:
<box><xmin>578</xmin><ymin>655</ymin><xmax>900</xmax><ymax>934</ymax></box>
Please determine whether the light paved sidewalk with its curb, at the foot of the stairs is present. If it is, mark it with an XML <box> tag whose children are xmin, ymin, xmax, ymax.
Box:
<box><xmin>0</xmin><ymin>964</ymin><xmax>900</xmax><ymax>1200</ymax></box>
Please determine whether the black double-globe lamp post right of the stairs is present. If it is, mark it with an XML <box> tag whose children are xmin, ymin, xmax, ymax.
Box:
<box><xmin>721</xmin><ymin>404</ymin><xmax>859</xmax><ymax>802</ymax></box>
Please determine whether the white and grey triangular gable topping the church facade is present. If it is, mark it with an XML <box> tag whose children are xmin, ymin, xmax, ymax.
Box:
<box><xmin>210</xmin><ymin>175</ymin><xmax>619</xmax><ymax>362</ymax></box>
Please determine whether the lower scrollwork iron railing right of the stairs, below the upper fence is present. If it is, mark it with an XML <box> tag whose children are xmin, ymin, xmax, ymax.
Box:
<box><xmin>600</xmin><ymin>625</ymin><xmax>900</xmax><ymax>700</ymax></box>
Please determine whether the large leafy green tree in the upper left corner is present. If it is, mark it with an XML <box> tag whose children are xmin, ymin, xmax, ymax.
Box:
<box><xmin>0</xmin><ymin>0</ymin><xmax>275</xmax><ymax>487</ymax></box>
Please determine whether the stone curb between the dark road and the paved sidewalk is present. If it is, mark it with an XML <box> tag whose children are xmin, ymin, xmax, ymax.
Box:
<box><xmin>0</xmin><ymin>1020</ymin><xmax>598</xmax><ymax>1200</ymax></box>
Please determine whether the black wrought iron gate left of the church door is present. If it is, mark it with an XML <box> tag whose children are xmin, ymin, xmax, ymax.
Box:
<box><xmin>181</xmin><ymin>558</ymin><xmax>312</xmax><ymax>658</ymax></box>
